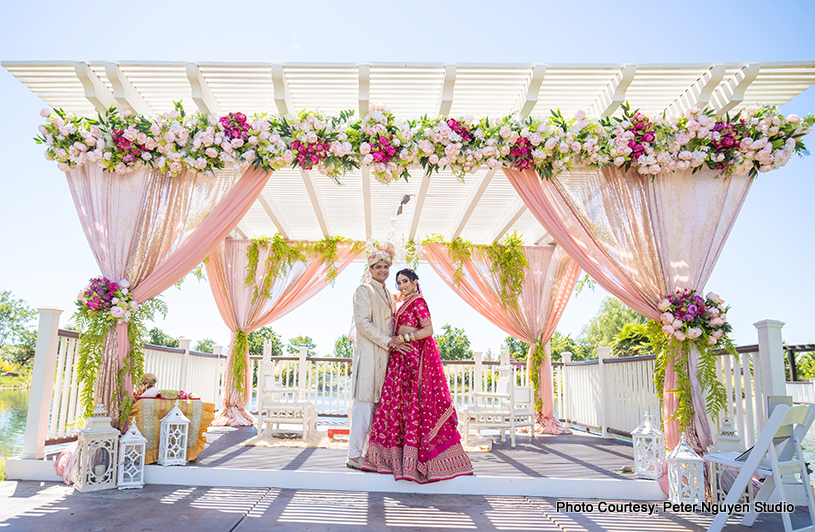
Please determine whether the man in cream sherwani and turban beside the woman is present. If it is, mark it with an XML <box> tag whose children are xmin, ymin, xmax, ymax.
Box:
<box><xmin>345</xmin><ymin>245</ymin><xmax>402</xmax><ymax>469</ymax></box>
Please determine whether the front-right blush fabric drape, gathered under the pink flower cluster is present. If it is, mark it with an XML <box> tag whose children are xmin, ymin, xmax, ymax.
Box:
<box><xmin>504</xmin><ymin>164</ymin><xmax>752</xmax><ymax>450</ymax></box>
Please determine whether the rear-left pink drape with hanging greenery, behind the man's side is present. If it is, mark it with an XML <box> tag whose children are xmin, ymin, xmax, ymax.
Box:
<box><xmin>206</xmin><ymin>238</ymin><xmax>356</xmax><ymax>427</ymax></box>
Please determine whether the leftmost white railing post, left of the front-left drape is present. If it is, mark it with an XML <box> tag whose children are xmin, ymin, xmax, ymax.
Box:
<box><xmin>20</xmin><ymin>307</ymin><xmax>62</xmax><ymax>460</ymax></box>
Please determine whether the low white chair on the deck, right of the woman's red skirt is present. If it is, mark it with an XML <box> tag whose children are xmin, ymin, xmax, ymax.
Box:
<box><xmin>459</xmin><ymin>365</ymin><xmax>535</xmax><ymax>449</ymax></box>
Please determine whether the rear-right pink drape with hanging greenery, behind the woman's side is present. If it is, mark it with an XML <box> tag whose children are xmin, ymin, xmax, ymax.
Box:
<box><xmin>422</xmin><ymin>244</ymin><xmax>580</xmax><ymax>434</ymax></box>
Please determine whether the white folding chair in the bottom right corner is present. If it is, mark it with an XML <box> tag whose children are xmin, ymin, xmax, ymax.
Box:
<box><xmin>705</xmin><ymin>405</ymin><xmax>815</xmax><ymax>532</ymax></box>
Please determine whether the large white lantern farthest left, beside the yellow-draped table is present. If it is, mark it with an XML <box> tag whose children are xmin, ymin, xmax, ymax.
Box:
<box><xmin>74</xmin><ymin>404</ymin><xmax>119</xmax><ymax>492</ymax></box>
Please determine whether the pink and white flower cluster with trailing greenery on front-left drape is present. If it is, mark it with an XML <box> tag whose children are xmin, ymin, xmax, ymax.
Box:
<box><xmin>74</xmin><ymin>277</ymin><xmax>167</xmax><ymax>424</ymax></box>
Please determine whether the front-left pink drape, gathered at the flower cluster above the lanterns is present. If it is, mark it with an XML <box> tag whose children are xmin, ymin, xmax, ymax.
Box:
<box><xmin>66</xmin><ymin>165</ymin><xmax>269</xmax><ymax>420</ymax></box>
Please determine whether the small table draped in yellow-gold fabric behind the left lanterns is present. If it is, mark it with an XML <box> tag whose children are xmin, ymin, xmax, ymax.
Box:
<box><xmin>130</xmin><ymin>398</ymin><xmax>215</xmax><ymax>464</ymax></box>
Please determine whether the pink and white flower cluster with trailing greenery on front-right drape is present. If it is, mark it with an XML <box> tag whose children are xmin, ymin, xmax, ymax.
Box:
<box><xmin>648</xmin><ymin>288</ymin><xmax>736</xmax><ymax>431</ymax></box>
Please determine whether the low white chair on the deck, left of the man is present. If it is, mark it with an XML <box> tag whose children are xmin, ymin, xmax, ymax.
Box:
<box><xmin>257</xmin><ymin>360</ymin><xmax>317</xmax><ymax>440</ymax></box>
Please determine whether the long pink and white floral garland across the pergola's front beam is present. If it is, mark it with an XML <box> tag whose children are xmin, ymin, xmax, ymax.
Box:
<box><xmin>35</xmin><ymin>103</ymin><xmax>815</xmax><ymax>183</ymax></box>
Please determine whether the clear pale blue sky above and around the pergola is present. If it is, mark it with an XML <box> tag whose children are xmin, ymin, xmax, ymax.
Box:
<box><xmin>0</xmin><ymin>0</ymin><xmax>815</xmax><ymax>352</ymax></box>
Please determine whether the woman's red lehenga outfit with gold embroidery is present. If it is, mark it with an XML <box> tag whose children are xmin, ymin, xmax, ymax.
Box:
<box><xmin>362</xmin><ymin>294</ymin><xmax>473</xmax><ymax>484</ymax></box>
